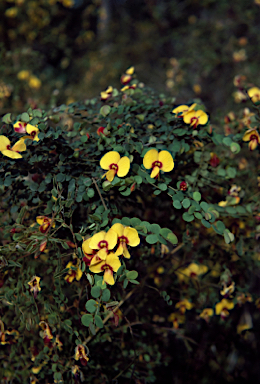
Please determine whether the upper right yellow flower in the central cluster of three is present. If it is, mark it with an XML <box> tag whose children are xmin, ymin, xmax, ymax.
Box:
<box><xmin>111</xmin><ymin>223</ymin><xmax>140</xmax><ymax>259</ymax></box>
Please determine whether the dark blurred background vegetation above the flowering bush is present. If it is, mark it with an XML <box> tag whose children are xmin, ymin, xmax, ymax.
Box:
<box><xmin>0</xmin><ymin>0</ymin><xmax>260</xmax><ymax>121</ymax></box>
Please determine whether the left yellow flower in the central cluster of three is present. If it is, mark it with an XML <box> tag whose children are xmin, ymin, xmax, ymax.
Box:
<box><xmin>89</xmin><ymin>228</ymin><xmax>117</xmax><ymax>264</ymax></box>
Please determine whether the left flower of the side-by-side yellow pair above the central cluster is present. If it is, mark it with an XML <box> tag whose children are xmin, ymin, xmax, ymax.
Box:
<box><xmin>100</xmin><ymin>151</ymin><xmax>130</xmax><ymax>181</ymax></box>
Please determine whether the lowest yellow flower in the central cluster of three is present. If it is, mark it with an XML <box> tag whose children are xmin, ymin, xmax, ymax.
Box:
<box><xmin>89</xmin><ymin>252</ymin><xmax>121</xmax><ymax>285</ymax></box>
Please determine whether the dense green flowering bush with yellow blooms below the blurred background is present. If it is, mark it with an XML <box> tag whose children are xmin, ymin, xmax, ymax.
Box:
<box><xmin>0</xmin><ymin>67</ymin><xmax>260</xmax><ymax>383</ymax></box>
